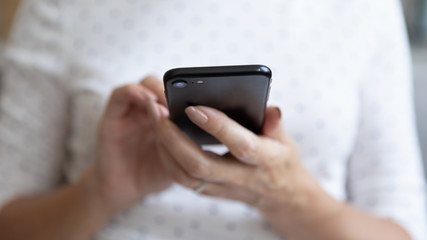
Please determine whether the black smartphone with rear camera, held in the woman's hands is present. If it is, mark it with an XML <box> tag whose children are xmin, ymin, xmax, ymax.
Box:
<box><xmin>163</xmin><ymin>65</ymin><xmax>272</xmax><ymax>145</ymax></box>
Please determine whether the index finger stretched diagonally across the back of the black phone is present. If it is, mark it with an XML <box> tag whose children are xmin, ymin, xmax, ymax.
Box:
<box><xmin>185</xmin><ymin>106</ymin><xmax>261</xmax><ymax>165</ymax></box>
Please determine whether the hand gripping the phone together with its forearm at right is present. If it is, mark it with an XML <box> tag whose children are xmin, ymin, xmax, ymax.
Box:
<box><xmin>149</xmin><ymin>105</ymin><xmax>410</xmax><ymax>240</ymax></box>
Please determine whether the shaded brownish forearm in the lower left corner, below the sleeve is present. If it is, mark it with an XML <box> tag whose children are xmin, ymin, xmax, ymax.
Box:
<box><xmin>0</xmin><ymin>169</ymin><xmax>112</xmax><ymax>240</ymax></box>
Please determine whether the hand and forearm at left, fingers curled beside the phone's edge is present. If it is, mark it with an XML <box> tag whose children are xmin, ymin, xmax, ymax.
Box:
<box><xmin>0</xmin><ymin>76</ymin><xmax>172</xmax><ymax>240</ymax></box>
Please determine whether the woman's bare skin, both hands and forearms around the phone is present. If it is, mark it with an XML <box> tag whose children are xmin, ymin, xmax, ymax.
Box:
<box><xmin>0</xmin><ymin>77</ymin><xmax>410</xmax><ymax>240</ymax></box>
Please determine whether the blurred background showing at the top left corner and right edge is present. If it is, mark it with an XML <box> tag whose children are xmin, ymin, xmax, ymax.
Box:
<box><xmin>0</xmin><ymin>0</ymin><xmax>427</xmax><ymax>171</ymax></box>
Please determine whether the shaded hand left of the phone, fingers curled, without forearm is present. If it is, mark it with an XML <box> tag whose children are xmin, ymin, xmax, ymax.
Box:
<box><xmin>89</xmin><ymin>76</ymin><xmax>171</xmax><ymax>211</ymax></box>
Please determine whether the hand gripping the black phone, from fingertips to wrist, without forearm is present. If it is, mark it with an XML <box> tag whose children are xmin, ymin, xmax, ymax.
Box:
<box><xmin>149</xmin><ymin>106</ymin><xmax>338</xmax><ymax>232</ymax></box>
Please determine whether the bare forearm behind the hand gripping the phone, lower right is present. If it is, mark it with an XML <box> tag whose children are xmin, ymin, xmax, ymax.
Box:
<box><xmin>265</xmin><ymin>182</ymin><xmax>411</xmax><ymax>240</ymax></box>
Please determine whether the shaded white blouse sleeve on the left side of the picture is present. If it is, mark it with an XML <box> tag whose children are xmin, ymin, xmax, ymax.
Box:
<box><xmin>0</xmin><ymin>0</ymin><xmax>67</xmax><ymax>207</ymax></box>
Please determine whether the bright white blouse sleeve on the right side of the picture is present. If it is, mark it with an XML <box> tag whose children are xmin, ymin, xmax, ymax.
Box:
<box><xmin>347</xmin><ymin>1</ymin><xmax>427</xmax><ymax>240</ymax></box>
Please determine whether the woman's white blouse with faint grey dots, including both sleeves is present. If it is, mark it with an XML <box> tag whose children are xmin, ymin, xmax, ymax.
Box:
<box><xmin>0</xmin><ymin>0</ymin><xmax>427</xmax><ymax>240</ymax></box>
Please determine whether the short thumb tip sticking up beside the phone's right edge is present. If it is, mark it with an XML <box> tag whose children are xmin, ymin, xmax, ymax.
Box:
<box><xmin>262</xmin><ymin>106</ymin><xmax>286</xmax><ymax>141</ymax></box>
